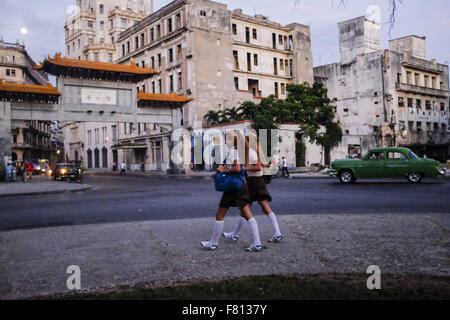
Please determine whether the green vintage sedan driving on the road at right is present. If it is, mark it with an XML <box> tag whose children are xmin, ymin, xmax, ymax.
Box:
<box><xmin>330</xmin><ymin>148</ymin><xmax>445</xmax><ymax>184</ymax></box>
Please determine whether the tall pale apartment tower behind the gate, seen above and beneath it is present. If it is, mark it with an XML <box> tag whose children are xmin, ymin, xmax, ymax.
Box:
<box><xmin>64</xmin><ymin>0</ymin><xmax>153</xmax><ymax>171</ymax></box>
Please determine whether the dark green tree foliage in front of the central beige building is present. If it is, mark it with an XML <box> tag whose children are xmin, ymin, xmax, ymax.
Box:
<box><xmin>205</xmin><ymin>82</ymin><xmax>342</xmax><ymax>148</ymax></box>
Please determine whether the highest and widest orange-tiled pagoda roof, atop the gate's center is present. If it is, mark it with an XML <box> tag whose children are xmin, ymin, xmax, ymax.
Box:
<box><xmin>34</xmin><ymin>53</ymin><xmax>158</xmax><ymax>83</ymax></box>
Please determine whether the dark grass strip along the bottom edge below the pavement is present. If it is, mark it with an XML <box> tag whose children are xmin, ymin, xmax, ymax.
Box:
<box><xmin>36</xmin><ymin>274</ymin><xmax>450</xmax><ymax>300</ymax></box>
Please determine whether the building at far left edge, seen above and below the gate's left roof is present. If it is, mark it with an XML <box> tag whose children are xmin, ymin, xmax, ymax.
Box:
<box><xmin>0</xmin><ymin>39</ymin><xmax>60</xmax><ymax>161</ymax></box>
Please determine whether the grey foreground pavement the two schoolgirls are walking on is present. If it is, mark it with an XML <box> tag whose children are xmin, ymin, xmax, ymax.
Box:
<box><xmin>0</xmin><ymin>214</ymin><xmax>450</xmax><ymax>299</ymax></box>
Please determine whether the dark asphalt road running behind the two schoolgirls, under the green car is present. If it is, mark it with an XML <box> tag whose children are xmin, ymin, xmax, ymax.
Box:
<box><xmin>0</xmin><ymin>175</ymin><xmax>450</xmax><ymax>231</ymax></box>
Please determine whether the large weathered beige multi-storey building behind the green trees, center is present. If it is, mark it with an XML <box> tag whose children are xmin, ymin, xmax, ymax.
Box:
<box><xmin>116</xmin><ymin>0</ymin><xmax>313</xmax><ymax>169</ymax></box>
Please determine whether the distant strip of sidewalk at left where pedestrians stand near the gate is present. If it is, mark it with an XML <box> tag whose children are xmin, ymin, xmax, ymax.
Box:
<box><xmin>0</xmin><ymin>176</ymin><xmax>92</xmax><ymax>197</ymax></box>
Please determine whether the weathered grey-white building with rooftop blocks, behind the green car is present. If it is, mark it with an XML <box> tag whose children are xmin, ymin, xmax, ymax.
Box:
<box><xmin>314</xmin><ymin>17</ymin><xmax>449</xmax><ymax>161</ymax></box>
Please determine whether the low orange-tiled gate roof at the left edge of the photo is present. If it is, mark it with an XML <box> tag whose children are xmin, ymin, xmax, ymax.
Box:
<box><xmin>0</xmin><ymin>79</ymin><xmax>61</xmax><ymax>103</ymax></box>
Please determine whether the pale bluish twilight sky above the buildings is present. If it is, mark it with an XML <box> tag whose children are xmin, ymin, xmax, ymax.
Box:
<box><xmin>0</xmin><ymin>0</ymin><xmax>450</xmax><ymax>66</ymax></box>
